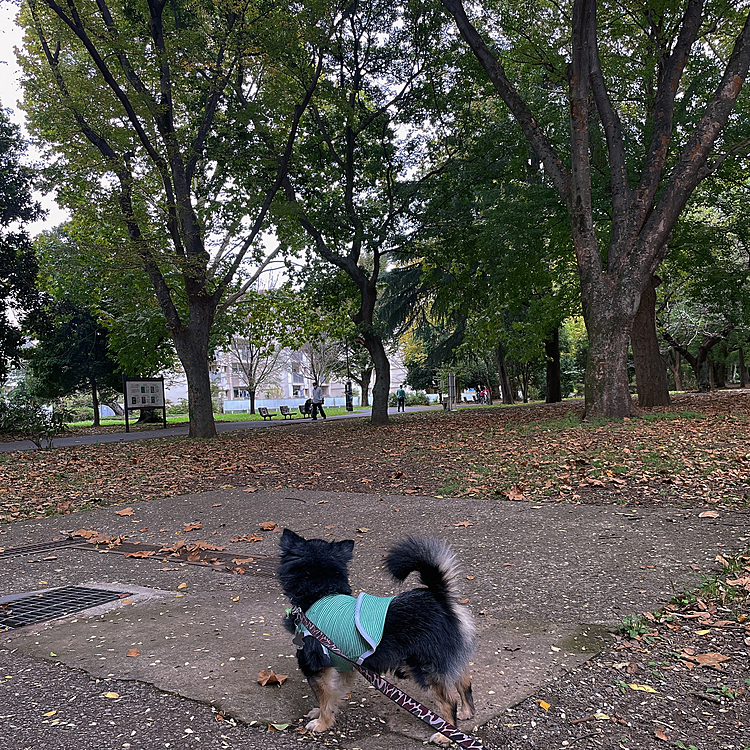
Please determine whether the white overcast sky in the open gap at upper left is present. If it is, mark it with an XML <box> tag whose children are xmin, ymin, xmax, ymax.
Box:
<box><xmin>0</xmin><ymin>0</ymin><xmax>67</xmax><ymax>236</ymax></box>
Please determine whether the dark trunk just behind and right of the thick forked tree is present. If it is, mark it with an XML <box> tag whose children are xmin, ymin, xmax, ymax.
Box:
<box><xmin>630</xmin><ymin>275</ymin><xmax>671</xmax><ymax>406</ymax></box>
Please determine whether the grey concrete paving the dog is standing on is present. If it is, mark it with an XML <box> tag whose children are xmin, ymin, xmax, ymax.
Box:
<box><xmin>0</xmin><ymin>489</ymin><xmax>750</xmax><ymax>750</ymax></box>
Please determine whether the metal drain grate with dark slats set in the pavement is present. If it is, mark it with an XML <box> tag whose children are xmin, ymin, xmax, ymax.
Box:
<box><xmin>0</xmin><ymin>586</ymin><xmax>130</xmax><ymax>632</ymax></box>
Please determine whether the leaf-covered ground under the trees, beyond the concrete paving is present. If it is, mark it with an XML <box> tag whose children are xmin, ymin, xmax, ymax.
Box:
<box><xmin>0</xmin><ymin>392</ymin><xmax>750</xmax><ymax>522</ymax></box>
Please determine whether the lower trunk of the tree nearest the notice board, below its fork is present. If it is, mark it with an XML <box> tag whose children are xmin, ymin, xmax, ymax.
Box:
<box><xmin>177</xmin><ymin>314</ymin><xmax>216</xmax><ymax>438</ymax></box>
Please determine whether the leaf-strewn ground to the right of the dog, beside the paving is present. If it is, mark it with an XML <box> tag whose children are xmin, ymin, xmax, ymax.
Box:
<box><xmin>482</xmin><ymin>555</ymin><xmax>750</xmax><ymax>750</ymax></box>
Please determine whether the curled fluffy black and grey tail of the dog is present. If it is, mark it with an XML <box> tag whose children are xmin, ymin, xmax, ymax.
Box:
<box><xmin>385</xmin><ymin>536</ymin><xmax>468</xmax><ymax>605</ymax></box>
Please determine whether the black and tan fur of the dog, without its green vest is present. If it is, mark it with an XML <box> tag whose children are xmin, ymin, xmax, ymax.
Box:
<box><xmin>278</xmin><ymin>529</ymin><xmax>474</xmax><ymax>743</ymax></box>
